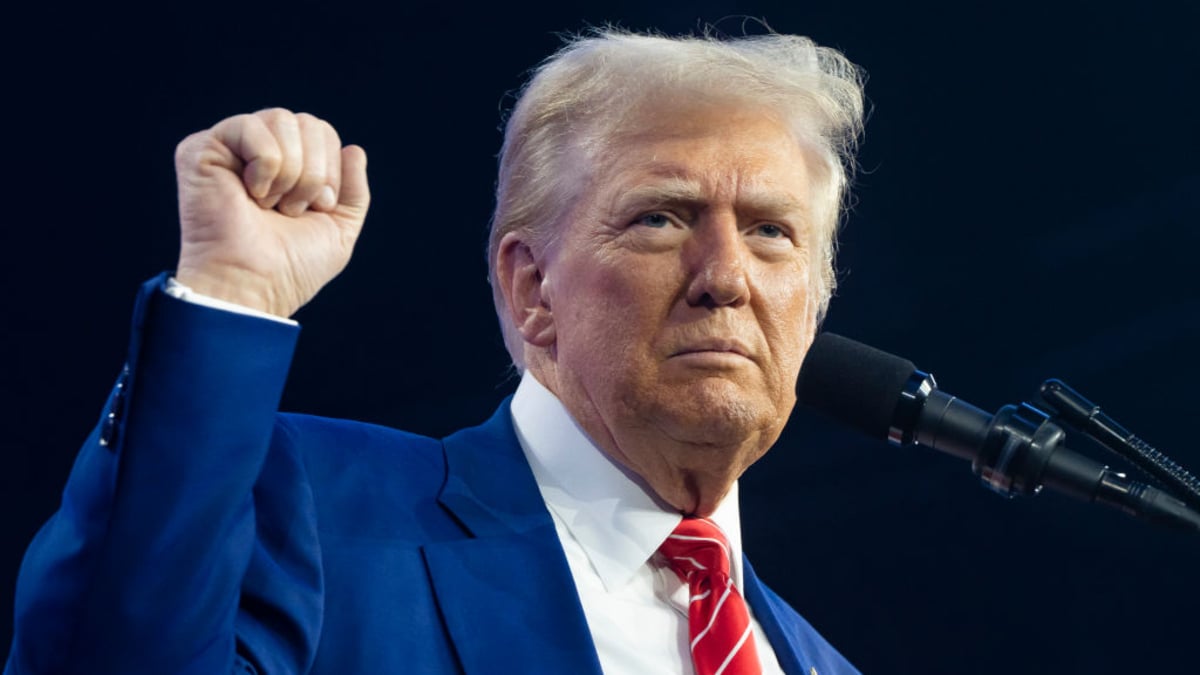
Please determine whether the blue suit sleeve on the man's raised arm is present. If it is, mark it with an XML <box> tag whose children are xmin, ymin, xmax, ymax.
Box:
<box><xmin>5</xmin><ymin>276</ymin><xmax>319</xmax><ymax>675</ymax></box>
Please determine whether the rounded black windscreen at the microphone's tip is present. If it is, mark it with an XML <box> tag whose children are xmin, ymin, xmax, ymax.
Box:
<box><xmin>796</xmin><ymin>333</ymin><xmax>917</xmax><ymax>440</ymax></box>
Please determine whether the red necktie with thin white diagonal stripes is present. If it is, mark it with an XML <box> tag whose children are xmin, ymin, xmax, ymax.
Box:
<box><xmin>659</xmin><ymin>518</ymin><xmax>762</xmax><ymax>675</ymax></box>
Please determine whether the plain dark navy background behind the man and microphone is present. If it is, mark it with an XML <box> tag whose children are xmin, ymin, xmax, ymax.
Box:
<box><xmin>0</xmin><ymin>0</ymin><xmax>1200</xmax><ymax>675</ymax></box>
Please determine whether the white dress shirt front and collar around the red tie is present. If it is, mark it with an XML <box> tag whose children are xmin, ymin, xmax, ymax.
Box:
<box><xmin>512</xmin><ymin>372</ymin><xmax>782</xmax><ymax>675</ymax></box>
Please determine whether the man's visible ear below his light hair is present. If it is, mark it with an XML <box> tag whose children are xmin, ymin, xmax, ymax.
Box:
<box><xmin>496</xmin><ymin>232</ymin><xmax>556</xmax><ymax>347</ymax></box>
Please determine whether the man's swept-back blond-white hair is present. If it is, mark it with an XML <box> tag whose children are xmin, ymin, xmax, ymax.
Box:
<box><xmin>487</xmin><ymin>29</ymin><xmax>863</xmax><ymax>368</ymax></box>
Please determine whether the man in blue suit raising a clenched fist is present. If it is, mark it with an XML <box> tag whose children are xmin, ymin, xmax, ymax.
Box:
<box><xmin>5</xmin><ymin>27</ymin><xmax>862</xmax><ymax>675</ymax></box>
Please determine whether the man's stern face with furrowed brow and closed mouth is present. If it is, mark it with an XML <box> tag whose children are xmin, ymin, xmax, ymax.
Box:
<box><xmin>535</xmin><ymin>102</ymin><xmax>818</xmax><ymax>504</ymax></box>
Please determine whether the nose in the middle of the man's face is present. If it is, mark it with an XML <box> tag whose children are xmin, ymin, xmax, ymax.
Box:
<box><xmin>685</xmin><ymin>214</ymin><xmax>750</xmax><ymax>307</ymax></box>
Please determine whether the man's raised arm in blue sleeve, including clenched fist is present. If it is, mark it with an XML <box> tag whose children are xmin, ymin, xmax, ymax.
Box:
<box><xmin>5</xmin><ymin>109</ymin><xmax>368</xmax><ymax>675</ymax></box>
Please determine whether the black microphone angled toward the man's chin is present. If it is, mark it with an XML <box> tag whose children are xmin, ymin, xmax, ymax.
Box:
<box><xmin>797</xmin><ymin>333</ymin><xmax>1200</xmax><ymax>531</ymax></box>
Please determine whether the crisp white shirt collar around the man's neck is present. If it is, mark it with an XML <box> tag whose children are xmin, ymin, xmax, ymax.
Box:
<box><xmin>511</xmin><ymin>371</ymin><xmax>742</xmax><ymax>591</ymax></box>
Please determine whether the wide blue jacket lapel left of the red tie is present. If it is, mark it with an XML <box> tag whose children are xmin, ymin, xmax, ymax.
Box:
<box><xmin>424</xmin><ymin>401</ymin><xmax>600</xmax><ymax>675</ymax></box>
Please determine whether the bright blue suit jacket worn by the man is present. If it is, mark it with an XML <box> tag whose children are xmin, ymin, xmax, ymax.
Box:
<box><xmin>5</xmin><ymin>279</ymin><xmax>857</xmax><ymax>675</ymax></box>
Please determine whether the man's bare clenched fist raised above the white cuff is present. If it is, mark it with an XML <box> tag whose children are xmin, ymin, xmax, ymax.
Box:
<box><xmin>175</xmin><ymin>108</ymin><xmax>371</xmax><ymax>317</ymax></box>
